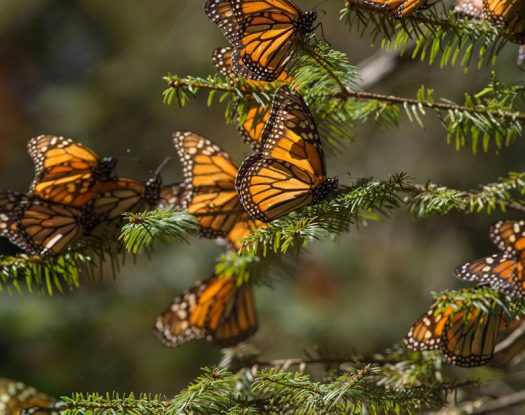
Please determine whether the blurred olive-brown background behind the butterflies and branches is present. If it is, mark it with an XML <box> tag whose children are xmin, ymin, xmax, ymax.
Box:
<box><xmin>0</xmin><ymin>0</ymin><xmax>525</xmax><ymax>396</ymax></box>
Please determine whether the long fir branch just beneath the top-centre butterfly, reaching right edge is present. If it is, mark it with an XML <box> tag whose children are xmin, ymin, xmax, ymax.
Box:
<box><xmin>164</xmin><ymin>61</ymin><xmax>525</xmax><ymax>153</ymax></box>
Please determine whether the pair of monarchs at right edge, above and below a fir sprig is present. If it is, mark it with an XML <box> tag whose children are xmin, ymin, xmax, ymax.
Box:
<box><xmin>405</xmin><ymin>221</ymin><xmax>525</xmax><ymax>367</ymax></box>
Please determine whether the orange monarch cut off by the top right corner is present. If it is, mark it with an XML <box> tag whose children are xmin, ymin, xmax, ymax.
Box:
<box><xmin>483</xmin><ymin>0</ymin><xmax>525</xmax><ymax>44</ymax></box>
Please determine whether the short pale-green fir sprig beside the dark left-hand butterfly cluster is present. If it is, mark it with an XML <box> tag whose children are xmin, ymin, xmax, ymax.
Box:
<box><xmin>119</xmin><ymin>209</ymin><xmax>199</xmax><ymax>254</ymax></box>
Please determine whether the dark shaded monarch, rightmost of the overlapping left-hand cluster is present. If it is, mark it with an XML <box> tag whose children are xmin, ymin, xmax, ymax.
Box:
<box><xmin>86</xmin><ymin>174</ymin><xmax>162</xmax><ymax>234</ymax></box>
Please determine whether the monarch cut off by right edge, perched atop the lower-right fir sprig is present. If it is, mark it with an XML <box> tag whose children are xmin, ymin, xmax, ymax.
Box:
<box><xmin>456</xmin><ymin>221</ymin><xmax>525</xmax><ymax>300</ymax></box>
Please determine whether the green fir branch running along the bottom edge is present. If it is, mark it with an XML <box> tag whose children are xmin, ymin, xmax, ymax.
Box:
<box><xmin>57</xmin><ymin>366</ymin><xmax>464</xmax><ymax>415</ymax></box>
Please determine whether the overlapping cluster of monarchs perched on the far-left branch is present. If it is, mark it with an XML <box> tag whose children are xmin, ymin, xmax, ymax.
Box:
<box><xmin>0</xmin><ymin>135</ymin><xmax>161</xmax><ymax>256</ymax></box>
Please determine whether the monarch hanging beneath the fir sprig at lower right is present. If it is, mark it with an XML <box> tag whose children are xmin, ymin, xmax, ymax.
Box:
<box><xmin>404</xmin><ymin>298</ymin><xmax>508</xmax><ymax>367</ymax></box>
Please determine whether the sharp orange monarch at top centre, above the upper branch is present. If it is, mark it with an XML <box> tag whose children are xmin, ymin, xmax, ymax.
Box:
<box><xmin>204</xmin><ymin>0</ymin><xmax>317</xmax><ymax>81</ymax></box>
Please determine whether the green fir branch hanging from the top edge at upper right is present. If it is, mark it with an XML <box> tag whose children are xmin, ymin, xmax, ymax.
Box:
<box><xmin>341</xmin><ymin>0</ymin><xmax>508</xmax><ymax>71</ymax></box>
